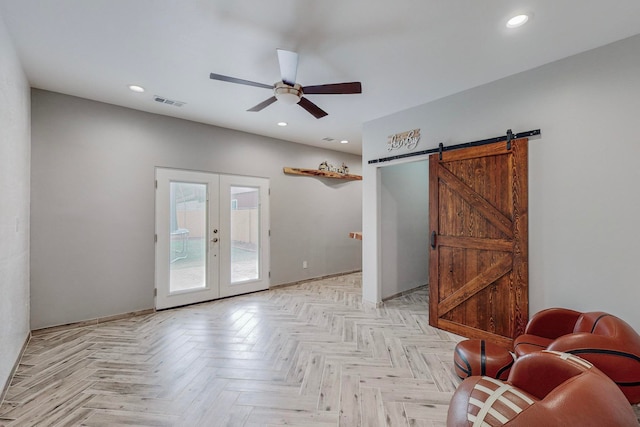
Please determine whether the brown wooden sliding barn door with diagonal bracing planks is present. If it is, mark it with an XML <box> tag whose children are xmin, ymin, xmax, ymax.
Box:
<box><xmin>429</xmin><ymin>138</ymin><xmax>529</xmax><ymax>347</ymax></box>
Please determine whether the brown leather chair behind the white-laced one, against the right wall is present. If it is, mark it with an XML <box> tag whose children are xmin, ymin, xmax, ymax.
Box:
<box><xmin>514</xmin><ymin>308</ymin><xmax>640</xmax><ymax>404</ymax></box>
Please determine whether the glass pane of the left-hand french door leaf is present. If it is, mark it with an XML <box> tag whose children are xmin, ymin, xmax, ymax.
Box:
<box><xmin>169</xmin><ymin>182</ymin><xmax>207</xmax><ymax>293</ymax></box>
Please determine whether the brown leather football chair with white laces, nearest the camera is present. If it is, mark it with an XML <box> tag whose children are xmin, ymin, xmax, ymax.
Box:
<box><xmin>447</xmin><ymin>351</ymin><xmax>638</xmax><ymax>427</ymax></box>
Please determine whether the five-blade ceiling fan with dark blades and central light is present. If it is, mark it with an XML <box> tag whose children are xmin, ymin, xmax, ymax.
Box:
<box><xmin>209</xmin><ymin>49</ymin><xmax>362</xmax><ymax>119</ymax></box>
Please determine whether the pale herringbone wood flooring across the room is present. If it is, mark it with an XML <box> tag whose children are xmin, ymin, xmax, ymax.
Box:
<box><xmin>0</xmin><ymin>273</ymin><xmax>459</xmax><ymax>427</ymax></box>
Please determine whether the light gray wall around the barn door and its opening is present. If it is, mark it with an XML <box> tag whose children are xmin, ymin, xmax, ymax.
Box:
<box><xmin>363</xmin><ymin>36</ymin><xmax>640</xmax><ymax>330</ymax></box>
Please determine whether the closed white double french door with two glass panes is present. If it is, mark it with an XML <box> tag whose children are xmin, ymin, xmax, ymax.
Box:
<box><xmin>155</xmin><ymin>168</ymin><xmax>269</xmax><ymax>309</ymax></box>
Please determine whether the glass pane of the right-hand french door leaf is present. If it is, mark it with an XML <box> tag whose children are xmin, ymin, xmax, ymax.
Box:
<box><xmin>230</xmin><ymin>186</ymin><xmax>260</xmax><ymax>283</ymax></box>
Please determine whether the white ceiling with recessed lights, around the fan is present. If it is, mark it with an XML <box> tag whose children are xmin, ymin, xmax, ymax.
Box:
<box><xmin>0</xmin><ymin>0</ymin><xmax>640</xmax><ymax>154</ymax></box>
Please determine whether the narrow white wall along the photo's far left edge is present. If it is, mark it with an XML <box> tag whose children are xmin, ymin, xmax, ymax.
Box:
<box><xmin>0</xmin><ymin>16</ymin><xmax>30</xmax><ymax>398</ymax></box>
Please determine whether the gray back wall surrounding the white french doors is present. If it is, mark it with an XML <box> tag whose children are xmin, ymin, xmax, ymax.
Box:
<box><xmin>31</xmin><ymin>90</ymin><xmax>362</xmax><ymax>329</ymax></box>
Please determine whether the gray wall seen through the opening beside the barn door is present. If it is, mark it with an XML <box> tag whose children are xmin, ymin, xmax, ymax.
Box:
<box><xmin>380</xmin><ymin>162</ymin><xmax>429</xmax><ymax>299</ymax></box>
